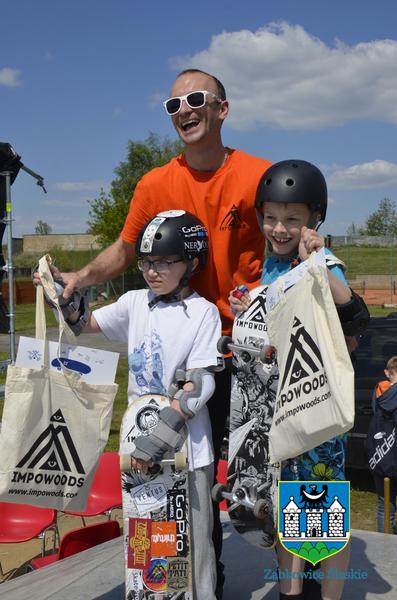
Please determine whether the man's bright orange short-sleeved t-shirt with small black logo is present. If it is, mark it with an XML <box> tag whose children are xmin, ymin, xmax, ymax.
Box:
<box><xmin>121</xmin><ymin>148</ymin><xmax>269</xmax><ymax>335</ymax></box>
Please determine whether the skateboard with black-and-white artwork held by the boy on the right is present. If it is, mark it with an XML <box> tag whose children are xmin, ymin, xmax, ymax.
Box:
<box><xmin>212</xmin><ymin>285</ymin><xmax>280</xmax><ymax>548</ymax></box>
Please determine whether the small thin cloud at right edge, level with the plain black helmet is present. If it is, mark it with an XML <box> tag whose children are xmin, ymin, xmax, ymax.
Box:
<box><xmin>327</xmin><ymin>160</ymin><xmax>397</xmax><ymax>190</ymax></box>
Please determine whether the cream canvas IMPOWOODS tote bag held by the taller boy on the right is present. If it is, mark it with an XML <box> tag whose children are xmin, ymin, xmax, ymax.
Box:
<box><xmin>267</xmin><ymin>253</ymin><xmax>354</xmax><ymax>463</ymax></box>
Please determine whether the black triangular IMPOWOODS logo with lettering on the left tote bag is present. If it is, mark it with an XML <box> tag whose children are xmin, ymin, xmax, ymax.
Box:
<box><xmin>11</xmin><ymin>410</ymin><xmax>85</xmax><ymax>487</ymax></box>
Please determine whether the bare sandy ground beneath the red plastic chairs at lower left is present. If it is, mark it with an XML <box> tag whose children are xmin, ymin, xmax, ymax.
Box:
<box><xmin>0</xmin><ymin>509</ymin><xmax>123</xmax><ymax>583</ymax></box>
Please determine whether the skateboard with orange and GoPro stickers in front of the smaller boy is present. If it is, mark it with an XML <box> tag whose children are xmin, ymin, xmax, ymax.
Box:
<box><xmin>120</xmin><ymin>394</ymin><xmax>193</xmax><ymax>600</ymax></box>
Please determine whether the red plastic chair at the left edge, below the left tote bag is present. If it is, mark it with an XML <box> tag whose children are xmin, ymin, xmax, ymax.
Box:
<box><xmin>0</xmin><ymin>502</ymin><xmax>59</xmax><ymax>576</ymax></box>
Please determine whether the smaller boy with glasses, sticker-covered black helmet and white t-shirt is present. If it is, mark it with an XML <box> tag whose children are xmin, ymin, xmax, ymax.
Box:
<box><xmin>66</xmin><ymin>210</ymin><xmax>223</xmax><ymax>600</ymax></box>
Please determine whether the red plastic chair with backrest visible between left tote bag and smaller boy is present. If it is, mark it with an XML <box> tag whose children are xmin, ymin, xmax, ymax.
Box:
<box><xmin>65</xmin><ymin>452</ymin><xmax>122</xmax><ymax>525</ymax></box>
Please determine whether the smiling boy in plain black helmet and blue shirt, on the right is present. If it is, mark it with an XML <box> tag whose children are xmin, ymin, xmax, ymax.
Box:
<box><xmin>229</xmin><ymin>160</ymin><xmax>369</xmax><ymax>600</ymax></box>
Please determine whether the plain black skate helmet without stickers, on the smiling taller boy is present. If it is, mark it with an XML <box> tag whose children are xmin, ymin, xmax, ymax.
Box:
<box><xmin>255</xmin><ymin>159</ymin><xmax>328</xmax><ymax>227</ymax></box>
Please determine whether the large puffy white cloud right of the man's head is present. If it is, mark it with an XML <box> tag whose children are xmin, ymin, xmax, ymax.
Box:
<box><xmin>171</xmin><ymin>22</ymin><xmax>397</xmax><ymax>129</ymax></box>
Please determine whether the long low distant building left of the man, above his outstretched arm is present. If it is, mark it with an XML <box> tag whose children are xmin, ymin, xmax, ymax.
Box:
<box><xmin>23</xmin><ymin>233</ymin><xmax>101</xmax><ymax>253</ymax></box>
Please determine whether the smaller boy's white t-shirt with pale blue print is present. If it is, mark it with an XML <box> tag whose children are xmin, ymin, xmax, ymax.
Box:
<box><xmin>93</xmin><ymin>289</ymin><xmax>222</xmax><ymax>470</ymax></box>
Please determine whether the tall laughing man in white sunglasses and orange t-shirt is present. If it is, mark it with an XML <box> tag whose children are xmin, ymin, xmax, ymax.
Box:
<box><xmin>45</xmin><ymin>69</ymin><xmax>270</xmax><ymax>598</ymax></box>
